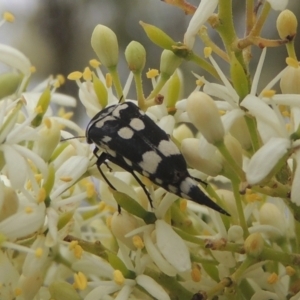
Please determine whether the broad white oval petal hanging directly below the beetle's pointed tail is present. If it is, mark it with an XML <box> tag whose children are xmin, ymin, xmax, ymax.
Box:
<box><xmin>155</xmin><ymin>220</ymin><xmax>191</xmax><ymax>272</ymax></box>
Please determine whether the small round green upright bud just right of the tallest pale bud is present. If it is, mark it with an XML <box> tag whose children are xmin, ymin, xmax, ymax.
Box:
<box><xmin>125</xmin><ymin>41</ymin><xmax>146</xmax><ymax>74</ymax></box>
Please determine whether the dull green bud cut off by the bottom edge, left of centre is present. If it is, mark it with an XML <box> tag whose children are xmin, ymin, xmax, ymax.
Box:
<box><xmin>49</xmin><ymin>281</ymin><xmax>81</xmax><ymax>300</ymax></box>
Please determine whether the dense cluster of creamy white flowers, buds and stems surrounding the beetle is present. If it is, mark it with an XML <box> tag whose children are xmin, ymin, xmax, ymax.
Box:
<box><xmin>0</xmin><ymin>0</ymin><xmax>300</xmax><ymax>300</ymax></box>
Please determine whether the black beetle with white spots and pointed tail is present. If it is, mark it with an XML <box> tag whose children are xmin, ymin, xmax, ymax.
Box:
<box><xmin>86</xmin><ymin>102</ymin><xmax>229</xmax><ymax>215</ymax></box>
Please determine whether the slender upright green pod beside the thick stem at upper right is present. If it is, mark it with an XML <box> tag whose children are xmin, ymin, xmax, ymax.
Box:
<box><xmin>230</xmin><ymin>55</ymin><xmax>249</xmax><ymax>99</ymax></box>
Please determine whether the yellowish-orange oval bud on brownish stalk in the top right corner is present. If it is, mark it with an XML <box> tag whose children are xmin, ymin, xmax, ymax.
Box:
<box><xmin>276</xmin><ymin>9</ymin><xmax>298</xmax><ymax>40</ymax></box>
